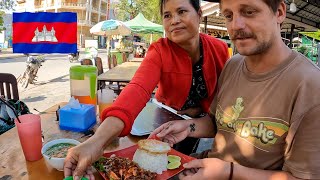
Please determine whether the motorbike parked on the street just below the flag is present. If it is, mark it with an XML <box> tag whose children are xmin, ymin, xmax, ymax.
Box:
<box><xmin>17</xmin><ymin>55</ymin><xmax>45</xmax><ymax>88</ymax></box>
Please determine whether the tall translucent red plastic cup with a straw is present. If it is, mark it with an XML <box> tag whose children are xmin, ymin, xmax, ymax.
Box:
<box><xmin>15</xmin><ymin>114</ymin><xmax>42</xmax><ymax>161</ymax></box>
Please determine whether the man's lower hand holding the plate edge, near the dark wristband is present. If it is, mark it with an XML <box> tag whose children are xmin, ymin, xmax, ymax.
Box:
<box><xmin>179</xmin><ymin>158</ymin><xmax>230</xmax><ymax>180</ymax></box>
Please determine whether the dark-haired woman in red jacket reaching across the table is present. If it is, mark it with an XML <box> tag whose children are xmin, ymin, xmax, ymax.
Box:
<box><xmin>64</xmin><ymin>0</ymin><xmax>228</xmax><ymax>179</ymax></box>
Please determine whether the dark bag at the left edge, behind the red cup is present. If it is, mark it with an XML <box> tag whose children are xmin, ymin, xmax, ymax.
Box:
<box><xmin>0</xmin><ymin>98</ymin><xmax>30</xmax><ymax>135</ymax></box>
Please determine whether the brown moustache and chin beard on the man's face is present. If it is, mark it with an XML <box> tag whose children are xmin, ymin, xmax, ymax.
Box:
<box><xmin>230</xmin><ymin>30</ymin><xmax>272</xmax><ymax>56</ymax></box>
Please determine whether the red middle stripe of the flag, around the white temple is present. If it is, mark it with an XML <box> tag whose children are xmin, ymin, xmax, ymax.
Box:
<box><xmin>12</xmin><ymin>22</ymin><xmax>77</xmax><ymax>43</ymax></box>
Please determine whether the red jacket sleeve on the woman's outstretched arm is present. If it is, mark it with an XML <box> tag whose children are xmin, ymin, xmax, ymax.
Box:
<box><xmin>101</xmin><ymin>45</ymin><xmax>162</xmax><ymax>136</ymax></box>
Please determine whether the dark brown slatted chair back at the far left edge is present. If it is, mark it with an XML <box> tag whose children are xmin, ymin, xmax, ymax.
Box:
<box><xmin>0</xmin><ymin>73</ymin><xmax>19</xmax><ymax>100</ymax></box>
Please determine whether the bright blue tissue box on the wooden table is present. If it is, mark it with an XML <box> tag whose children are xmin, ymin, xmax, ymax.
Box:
<box><xmin>59</xmin><ymin>104</ymin><xmax>96</xmax><ymax>132</ymax></box>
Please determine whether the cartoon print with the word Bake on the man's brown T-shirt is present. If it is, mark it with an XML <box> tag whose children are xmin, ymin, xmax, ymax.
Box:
<box><xmin>216</xmin><ymin>97</ymin><xmax>289</xmax><ymax>151</ymax></box>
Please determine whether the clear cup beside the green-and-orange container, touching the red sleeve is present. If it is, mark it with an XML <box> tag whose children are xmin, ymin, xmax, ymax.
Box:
<box><xmin>98</xmin><ymin>89</ymin><xmax>115</xmax><ymax>117</ymax></box>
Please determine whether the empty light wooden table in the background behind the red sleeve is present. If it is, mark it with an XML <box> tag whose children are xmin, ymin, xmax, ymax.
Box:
<box><xmin>98</xmin><ymin>62</ymin><xmax>141</xmax><ymax>83</ymax></box>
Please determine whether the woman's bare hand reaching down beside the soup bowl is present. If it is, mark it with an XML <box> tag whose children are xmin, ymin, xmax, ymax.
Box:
<box><xmin>64</xmin><ymin>139</ymin><xmax>103</xmax><ymax>180</ymax></box>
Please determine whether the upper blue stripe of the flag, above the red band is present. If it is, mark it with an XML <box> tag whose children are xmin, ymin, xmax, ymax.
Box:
<box><xmin>13</xmin><ymin>12</ymin><xmax>77</xmax><ymax>23</ymax></box>
